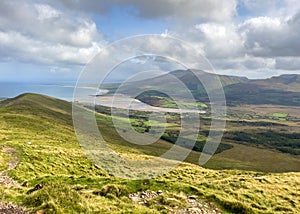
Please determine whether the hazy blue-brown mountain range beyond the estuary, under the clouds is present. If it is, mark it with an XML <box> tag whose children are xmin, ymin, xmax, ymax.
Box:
<box><xmin>105</xmin><ymin>70</ymin><xmax>300</xmax><ymax>106</ymax></box>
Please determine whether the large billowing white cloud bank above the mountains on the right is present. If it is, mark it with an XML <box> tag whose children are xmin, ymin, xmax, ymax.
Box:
<box><xmin>173</xmin><ymin>2</ymin><xmax>300</xmax><ymax>78</ymax></box>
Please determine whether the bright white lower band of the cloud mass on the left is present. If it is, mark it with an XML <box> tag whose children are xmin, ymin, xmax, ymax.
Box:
<box><xmin>0</xmin><ymin>32</ymin><xmax>100</xmax><ymax>65</ymax></box>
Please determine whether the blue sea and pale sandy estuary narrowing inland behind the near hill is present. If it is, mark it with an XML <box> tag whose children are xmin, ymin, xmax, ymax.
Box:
<box><xmin>0</xmin><ymin>82</ymin><xmax>205</xmax><ymax>113</ymax></box>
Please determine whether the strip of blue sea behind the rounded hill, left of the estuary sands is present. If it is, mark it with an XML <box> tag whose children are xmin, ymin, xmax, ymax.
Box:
<box><xmin>0</xmin><ymin>82</ymin><xmax>97</xmax><ymax>101</ymax></box>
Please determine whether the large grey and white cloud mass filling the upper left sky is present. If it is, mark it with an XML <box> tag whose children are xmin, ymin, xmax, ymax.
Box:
<box><xmin>0</xmin><ymin>0</ymin><xmax>103</xmax><ymax>66</ymax></box>
